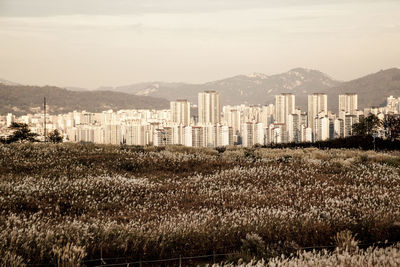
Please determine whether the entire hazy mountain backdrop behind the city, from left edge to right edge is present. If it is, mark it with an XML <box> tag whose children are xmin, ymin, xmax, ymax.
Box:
<box><xmin>0</xmin><ymin>68</ymin><xmax>400</xmax><ymax>113</ymax></box>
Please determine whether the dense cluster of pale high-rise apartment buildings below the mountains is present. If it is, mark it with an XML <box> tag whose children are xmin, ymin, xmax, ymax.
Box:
<box><xmin>0</xmin><ymin>91</ymin><xmax>400</xmax><ymax>147</ymax></box>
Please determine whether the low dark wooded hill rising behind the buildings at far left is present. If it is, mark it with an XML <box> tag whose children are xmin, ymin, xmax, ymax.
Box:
<box><xmin>0</xmin><ymin>84</ymin><xmax>169</xmax><ymax>115</ymax></box>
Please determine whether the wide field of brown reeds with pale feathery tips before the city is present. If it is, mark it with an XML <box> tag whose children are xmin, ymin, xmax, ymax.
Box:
<box><xmin>0</xmin><ymin>144</ymin><xmax>400</xmax><ymax>266</ymax></box>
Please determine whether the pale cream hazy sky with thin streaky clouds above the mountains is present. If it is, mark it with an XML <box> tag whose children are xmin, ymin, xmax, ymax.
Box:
<box><xmin>0</xmin><ymin>0</ymin><xmax>400</xmax><ymax>88</ymax></box>
